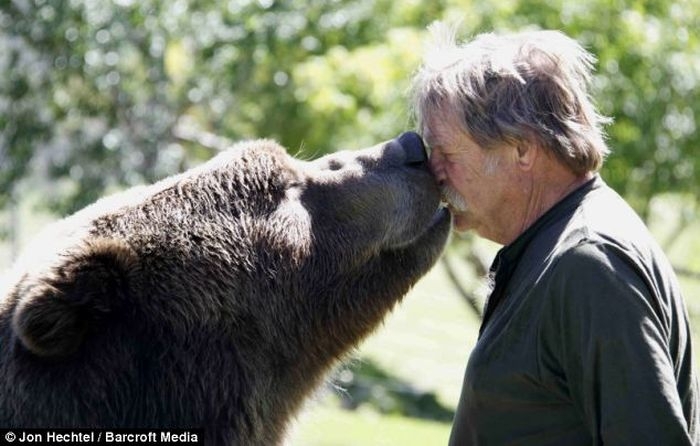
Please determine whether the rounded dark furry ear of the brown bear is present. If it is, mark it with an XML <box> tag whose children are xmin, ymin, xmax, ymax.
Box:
<box><xmin>12</xmin><ymin>239</ymin><xmax>137</xmax><ymax>358</ymax></box>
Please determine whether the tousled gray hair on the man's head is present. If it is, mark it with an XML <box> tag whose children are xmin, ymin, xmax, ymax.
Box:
<box><xmin>413</xmin><ymin>23</ymin><xmax>610</xmax><ymax>174</ymax></box>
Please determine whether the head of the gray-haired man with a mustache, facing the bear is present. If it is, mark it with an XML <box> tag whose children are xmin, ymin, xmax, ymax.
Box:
<box><xmin>413</xmin><ymin>24</ymin><xmax>608</xmax><ymax>243</ymax></box>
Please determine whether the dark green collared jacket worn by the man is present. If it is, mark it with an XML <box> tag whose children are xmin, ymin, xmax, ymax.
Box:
<box><xmin>450</xmin><ymin>177</ymin><xmax>700</xmax><ymax>446</ymax></box>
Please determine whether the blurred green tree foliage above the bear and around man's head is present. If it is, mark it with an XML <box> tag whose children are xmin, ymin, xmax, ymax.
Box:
<box><xmin>0</xmin><ymin>0</ymin><xmax>700</xmax><ymax>215</ymax></box>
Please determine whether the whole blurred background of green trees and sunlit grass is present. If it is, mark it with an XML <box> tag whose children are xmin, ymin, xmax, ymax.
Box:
<box><xmin>0</xmin><ymin>0</ymin><xmax>700</xmax><ymax>446</ymax></box>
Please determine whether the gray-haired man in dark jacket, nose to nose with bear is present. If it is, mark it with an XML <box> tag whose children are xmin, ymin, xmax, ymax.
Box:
<box><xmin>414</xmin><ymin>25</ymin><xmax>700</xmax><ymax>446</ymax></box>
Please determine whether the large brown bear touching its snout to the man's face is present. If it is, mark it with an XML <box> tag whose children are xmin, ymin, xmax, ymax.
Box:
<box><xmin>0</xmin><ymin>133</ymin><xmax>451</xmax><ymax>446</ymax></box>
